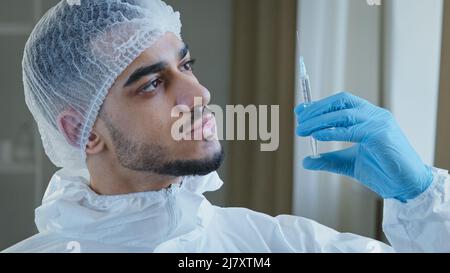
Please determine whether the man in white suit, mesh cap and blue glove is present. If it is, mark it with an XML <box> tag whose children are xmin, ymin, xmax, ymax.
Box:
<box><xmin>1</xmin><ymin>0</ymin><xmax>450</xmax><ymax>252</ymax></box>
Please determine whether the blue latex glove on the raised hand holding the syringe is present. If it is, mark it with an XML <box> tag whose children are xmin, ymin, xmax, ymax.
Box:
<box><xmin>295</xmin><ymin>93</ymin><xmax>433</xmax><ymax>202</ymax></box>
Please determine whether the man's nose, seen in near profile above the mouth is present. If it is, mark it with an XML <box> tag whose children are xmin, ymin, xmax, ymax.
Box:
<box><xmin>174</xmin><ymin>75</ymin><xmax>211</xmax><ymax>109</ymax></box>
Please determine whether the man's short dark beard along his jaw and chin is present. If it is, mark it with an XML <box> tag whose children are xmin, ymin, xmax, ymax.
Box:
<box><xmin>101</xmin><ymin>112</ymin><xmax>224</xmax><ymax>174</ymax></box>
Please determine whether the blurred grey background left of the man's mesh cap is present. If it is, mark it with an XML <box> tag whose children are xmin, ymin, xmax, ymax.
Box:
<box><xmin>0</xmin><ymin>0</ymin><xmax>61</xmax><ymax>249</ymax></box>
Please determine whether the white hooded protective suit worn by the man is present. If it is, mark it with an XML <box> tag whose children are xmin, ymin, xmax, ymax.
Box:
<box><xmin>5</xmin><ymin>169</ymin><xmax>450</xmax><ymax>252</ymax></box>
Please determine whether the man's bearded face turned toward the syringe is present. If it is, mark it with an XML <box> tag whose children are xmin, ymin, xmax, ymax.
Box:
<box><xmin>94</xmin><ymin>33</ymin><xmax>223</xmax><ymax>176</ymax></box>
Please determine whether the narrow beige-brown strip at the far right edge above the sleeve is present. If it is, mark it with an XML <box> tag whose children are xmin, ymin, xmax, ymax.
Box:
<box><xmin>436</xmin><ymin>1</ymin><xmax>450</xmax><ymax>170</ymax></box>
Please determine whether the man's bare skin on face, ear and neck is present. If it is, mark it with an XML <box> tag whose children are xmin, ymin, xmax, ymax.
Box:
<box><xmin>59</xmin><ymin>33</ymin><xmax>223</xmax><ymax>195</ymax></box>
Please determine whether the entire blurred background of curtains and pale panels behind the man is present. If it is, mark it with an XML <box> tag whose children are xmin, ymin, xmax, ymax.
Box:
<box><xmin>0</xmin><ymin>0</ymin><xmax>450</xmax><ymax>249</ymax></box>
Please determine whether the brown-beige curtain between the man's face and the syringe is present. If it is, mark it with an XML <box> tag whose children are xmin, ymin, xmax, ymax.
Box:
<box><xmin>226</xmin><ymin>0</ymin><xmax>297</xmax><ymax>215</ymax></box>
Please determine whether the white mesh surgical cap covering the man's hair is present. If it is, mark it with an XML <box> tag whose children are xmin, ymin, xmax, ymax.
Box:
<box><xmin>22</xmin><ymin>0</ymin><xmax>181</xmax><ymax>169</ymax></box>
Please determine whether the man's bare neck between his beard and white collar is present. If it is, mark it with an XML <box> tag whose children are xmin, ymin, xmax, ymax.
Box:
<box><xmin>87</xmin><ymin>154</ymin><xmax>182</xmax><ymax>195</ymax></box>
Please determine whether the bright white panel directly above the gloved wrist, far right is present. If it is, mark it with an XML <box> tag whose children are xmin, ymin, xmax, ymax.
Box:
<box><xmin>385</xmin><ymin>0</ymin><xmax>443</xmax><ymax>165</ymax></box>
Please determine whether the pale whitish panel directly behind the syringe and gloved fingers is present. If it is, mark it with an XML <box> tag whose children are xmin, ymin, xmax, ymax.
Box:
<box><xmin>293</xmin><ymin>0</ymin><xmax>381</xmax><ymax>237</ymax></box>
